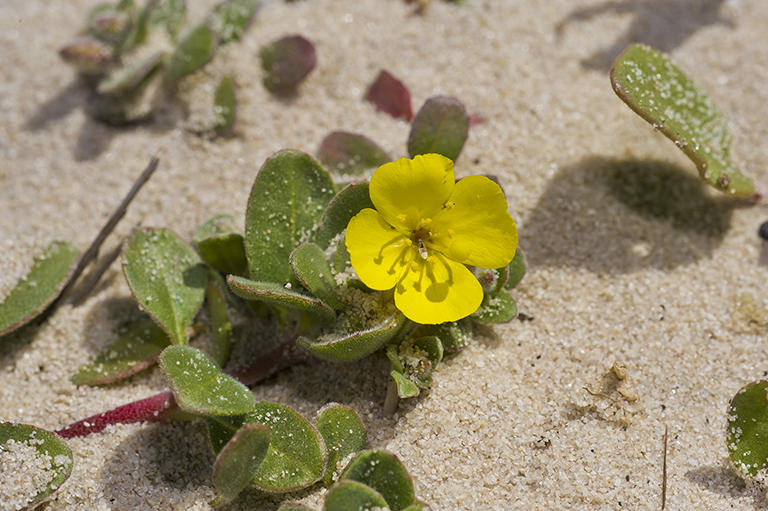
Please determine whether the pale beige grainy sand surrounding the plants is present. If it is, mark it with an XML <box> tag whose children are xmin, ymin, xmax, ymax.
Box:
<box><xmin>0</xmin><ymin>0</ymin><xmax>768</xmax><ymax>511</ymax></box>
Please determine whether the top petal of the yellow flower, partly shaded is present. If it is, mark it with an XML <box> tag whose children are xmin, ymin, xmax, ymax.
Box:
<box><xmin>369</xmin><ymin>154</ymin><xmax>455</xmax><ymax>231</ymax></box>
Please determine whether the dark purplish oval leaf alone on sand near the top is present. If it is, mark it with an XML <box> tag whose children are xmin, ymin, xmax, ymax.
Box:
<box><xmin>260</xmin><ymin>35</ymin><xmax>317</xmax><ymax>94</ymax></box>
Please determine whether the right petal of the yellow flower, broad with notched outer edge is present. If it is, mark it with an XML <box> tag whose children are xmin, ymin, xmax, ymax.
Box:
<box><xmin>430</xmin><ymin>176</ymin><xmax>517</xmax><ymax>268</ymax></box>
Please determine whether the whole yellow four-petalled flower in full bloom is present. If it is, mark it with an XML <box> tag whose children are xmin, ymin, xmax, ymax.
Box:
<box><xmin>346</xmin><ymin>154</ymin><xmax>517</xmax><ymax>324</ymax></box>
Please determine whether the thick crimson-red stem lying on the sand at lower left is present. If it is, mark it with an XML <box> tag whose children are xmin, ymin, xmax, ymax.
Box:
<box><xmin>56</xmin><ymin>391</ymin><xmax>178</xmax><ymax>438</ymax></box>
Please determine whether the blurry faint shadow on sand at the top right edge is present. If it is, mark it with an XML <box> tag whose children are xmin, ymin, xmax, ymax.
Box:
<box><xmin>556</xmin><ymin>0</ymin><xmax>733</xmax><ymax>71</ymax></box>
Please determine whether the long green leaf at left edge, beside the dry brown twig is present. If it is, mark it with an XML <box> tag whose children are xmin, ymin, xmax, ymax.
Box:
<box><xmin>0</xmin><ymin>241</ymin><xmax>79</xmax><ymax>336</ymax></box>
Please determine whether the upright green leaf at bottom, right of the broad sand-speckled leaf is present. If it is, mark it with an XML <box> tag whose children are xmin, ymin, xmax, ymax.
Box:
<box><xmin>315</xmin><ymin>403</ymin><xmax>368</xmax><ymax>487</ymax></box>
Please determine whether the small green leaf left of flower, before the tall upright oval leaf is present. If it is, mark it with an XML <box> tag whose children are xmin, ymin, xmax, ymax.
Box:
<box><xmin>290</xmin><ymin>243</ymin><xmax>346</xmax><ymax>309</ymax></box>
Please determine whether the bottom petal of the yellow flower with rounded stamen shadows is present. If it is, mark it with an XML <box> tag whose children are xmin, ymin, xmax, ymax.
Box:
<box><xmin>395</xmin><ymin>254</ymin><xmax>483</xmax><ymax>324</ymax></box>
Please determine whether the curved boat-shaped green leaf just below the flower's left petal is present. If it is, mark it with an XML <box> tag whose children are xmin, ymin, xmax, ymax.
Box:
<box><xmin>296</xmin><ymin>311</ymin><xmax>410</xmax><ymax>362</ymax></box>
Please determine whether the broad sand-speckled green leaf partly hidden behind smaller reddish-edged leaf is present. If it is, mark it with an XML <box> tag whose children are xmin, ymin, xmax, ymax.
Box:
<box><xmin>245</xmin><ymin>402</ymin><xmax>326</xmax><ymax>493</ymax></box>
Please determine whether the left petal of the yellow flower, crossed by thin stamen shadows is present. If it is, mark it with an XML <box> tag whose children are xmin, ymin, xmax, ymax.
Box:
<box><xmin>345</xmin><ymin>208</ymin><xmax>410</xmax><ymax>291</ymax></box>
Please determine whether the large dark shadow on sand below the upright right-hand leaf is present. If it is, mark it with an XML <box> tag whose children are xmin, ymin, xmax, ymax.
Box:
<box><xmin>520</xmin><ymin>157</ymin><xmax>751</xmax><ymax>274</ymax></box>
